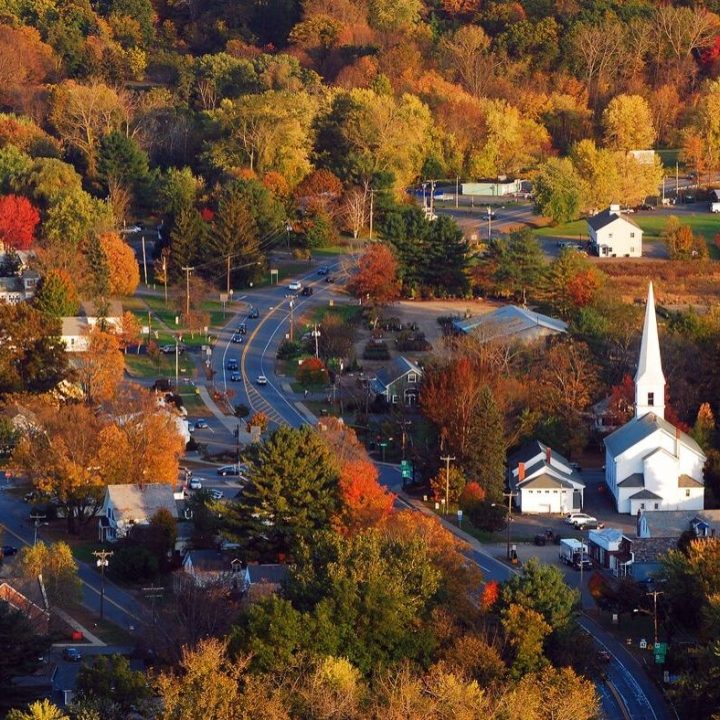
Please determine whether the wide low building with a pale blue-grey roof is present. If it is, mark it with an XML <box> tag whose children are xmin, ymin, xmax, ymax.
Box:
<box><xmin>453</xmin><ymin>305</ymin><xmax>568</xmax><ymax>343</ymax></box>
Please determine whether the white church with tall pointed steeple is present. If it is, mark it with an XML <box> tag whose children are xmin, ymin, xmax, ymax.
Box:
<box><xmin>605</xmin><ymin>283</ymin><xmax>705</xmax><ymax>515</ymax></box>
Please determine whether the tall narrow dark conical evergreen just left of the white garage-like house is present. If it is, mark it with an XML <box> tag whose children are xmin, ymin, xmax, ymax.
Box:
<box><xmin>464</xmin><ymin>386</ymin><xmax>506</xmax><ymax>502</ymax></box>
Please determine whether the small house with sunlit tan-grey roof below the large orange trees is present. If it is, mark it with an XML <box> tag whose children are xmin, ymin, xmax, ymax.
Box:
<box><xmin>98</xmin><ymin>483</ymin><xmax>178</xmax><ymax>542</ymax></box>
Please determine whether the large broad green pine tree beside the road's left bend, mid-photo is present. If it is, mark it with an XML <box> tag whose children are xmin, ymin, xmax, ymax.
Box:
<box><xmin>224</xmin><ymin>426</ymin><xmax>338</xmax><ymax>560</ymax></box>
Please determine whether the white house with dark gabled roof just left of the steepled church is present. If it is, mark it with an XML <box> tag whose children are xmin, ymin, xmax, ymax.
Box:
<box><xmin>508</xmin><ymin>440</ymin><xmax>585</xmax><ymax>513</ymax></box>
